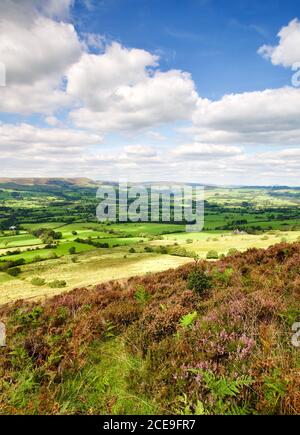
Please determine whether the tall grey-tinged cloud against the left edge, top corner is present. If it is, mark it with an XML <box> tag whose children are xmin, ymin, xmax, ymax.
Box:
<box><xmin>0</xmin><ymin>0</ymin><xmax>82</xmax><ymax>113</ymax></box>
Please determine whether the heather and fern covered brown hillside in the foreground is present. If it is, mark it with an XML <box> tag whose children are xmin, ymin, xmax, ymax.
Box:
<box><xmin>0</xmin><ymin>243</ymin><xmax>300</xmax><ymax>414</ymax></box>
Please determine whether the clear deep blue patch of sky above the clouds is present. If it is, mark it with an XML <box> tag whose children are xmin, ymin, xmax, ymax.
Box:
<box><xmin>74</xmin><ymin>0</ymin><xmax>300</xmax><ymax>99</ymax></box>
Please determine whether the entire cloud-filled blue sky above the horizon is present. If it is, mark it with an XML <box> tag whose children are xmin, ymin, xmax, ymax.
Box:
<box><xmin>0</xmin><ymin>0</ymin><xmax>300</xmax><ymax>186</ymax></box>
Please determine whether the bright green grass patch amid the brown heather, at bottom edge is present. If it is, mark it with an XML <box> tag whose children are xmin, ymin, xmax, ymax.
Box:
<box><xmin>58</xmin><ymin>337</ymin><xmax>158</xmax><ymax>415</ymax></box>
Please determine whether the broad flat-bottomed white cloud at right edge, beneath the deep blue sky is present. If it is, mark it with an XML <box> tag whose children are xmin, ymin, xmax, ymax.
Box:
<box><xmin>193</xmin><ymin>87</ymin><xmax>300</xmax><ymax>145</ymax></box>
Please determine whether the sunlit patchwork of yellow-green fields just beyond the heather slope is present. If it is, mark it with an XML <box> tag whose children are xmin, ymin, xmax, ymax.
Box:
<box><xmin>0</xmin><ymin>223</ymin><xmax>300</xmax><ymax>304</ymax></box>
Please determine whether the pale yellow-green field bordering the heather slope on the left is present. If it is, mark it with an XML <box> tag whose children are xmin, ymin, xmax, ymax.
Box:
<box><xmin>0</xmin><ymin>250</ymin><xmax>191</xmax><ymax>305</ymax></box>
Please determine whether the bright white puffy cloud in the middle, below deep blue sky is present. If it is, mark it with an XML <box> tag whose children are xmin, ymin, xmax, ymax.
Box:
<box><xmin>67</xmin><ymin>43</ymin><xmax>198</xmax><ymax>131</ymax></box>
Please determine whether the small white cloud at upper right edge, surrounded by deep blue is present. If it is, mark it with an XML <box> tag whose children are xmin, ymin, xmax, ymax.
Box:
<box><xmin>258</xmin><ymin>18</ymin><xmax>300</xmax><ymax>67</ymax></box>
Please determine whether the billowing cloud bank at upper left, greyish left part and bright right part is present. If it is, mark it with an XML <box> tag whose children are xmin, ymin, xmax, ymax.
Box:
<box><xmin>0</xmin><ymin>0</ymin><xmax>198</xmax><ymax>127</ymax></box>
